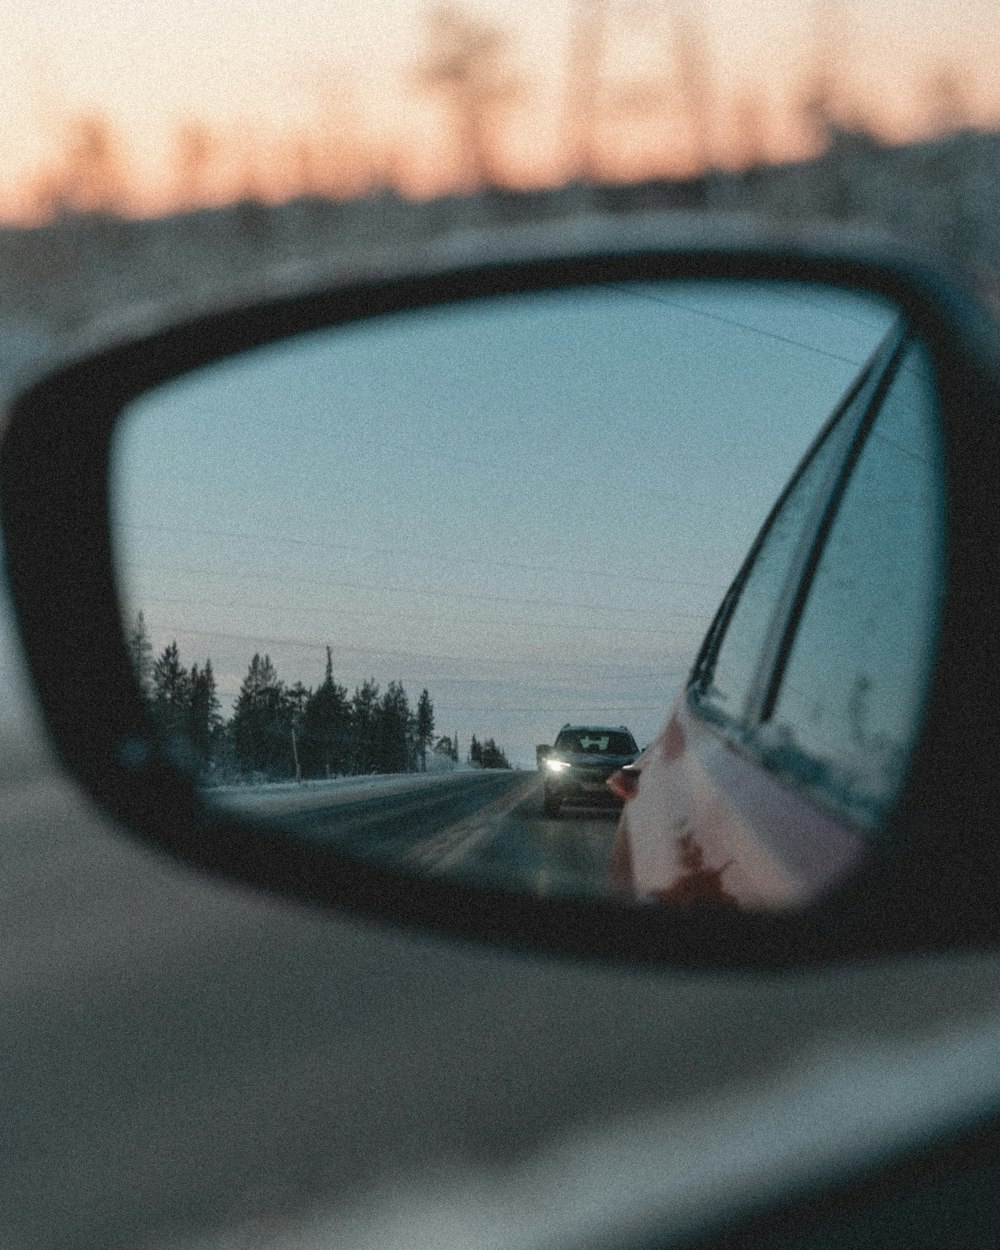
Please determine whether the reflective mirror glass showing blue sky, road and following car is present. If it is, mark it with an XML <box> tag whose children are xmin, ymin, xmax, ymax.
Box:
<box><xmin>113</xmin><ymin>281</ymin><xmax>943</xmax><ymax>906</ymax></box>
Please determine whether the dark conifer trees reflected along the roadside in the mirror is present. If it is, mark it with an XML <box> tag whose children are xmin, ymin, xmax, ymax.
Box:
<box><xmin>128</xmin><ymin>611</ymin><xmax>510</xmax><ymax>784</ymax></box>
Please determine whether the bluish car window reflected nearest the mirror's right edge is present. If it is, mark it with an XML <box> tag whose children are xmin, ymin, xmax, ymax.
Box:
<box><xmin>768</xmin><ymin>345</ymin><xmax>944</xmax><ymax>831</ymax></box>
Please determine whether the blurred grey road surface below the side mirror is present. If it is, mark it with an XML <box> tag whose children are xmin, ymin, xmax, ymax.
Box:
<box><xmin>0</xmin><ymin>750</ymin><xmax>1000</xmax><ymax>1250</ymax></box>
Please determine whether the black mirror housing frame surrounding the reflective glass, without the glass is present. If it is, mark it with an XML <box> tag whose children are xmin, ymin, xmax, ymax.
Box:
<box><xmin>0</xmin><ymin>216</ymin><xmax>1000</xmax><ymax>969</ymax></box>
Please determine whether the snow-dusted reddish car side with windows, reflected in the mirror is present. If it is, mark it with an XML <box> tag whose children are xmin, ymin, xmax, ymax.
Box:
<box><xmin>611</xmin><ymin>330</ymin><xmax>945</xmax><ymax>908</ymax></box>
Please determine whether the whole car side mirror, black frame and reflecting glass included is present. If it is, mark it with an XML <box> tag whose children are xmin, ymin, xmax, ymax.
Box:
<box><xmin>0</xmin><ymin>218</ymin><xmax>1000</xmax><ymax>966</ymax></box>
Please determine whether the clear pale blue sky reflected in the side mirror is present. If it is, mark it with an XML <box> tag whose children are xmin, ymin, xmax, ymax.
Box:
<box><xmin>115</xmin><ymin>284</ymin><xmax>890</xmax><ymax>766</ymax></box>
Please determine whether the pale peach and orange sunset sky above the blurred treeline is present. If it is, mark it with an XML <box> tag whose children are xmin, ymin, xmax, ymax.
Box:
<box><xmin>0</xmin><ymin>0</ymin><xmax>1000</xmax><ymax>218</ymax></box>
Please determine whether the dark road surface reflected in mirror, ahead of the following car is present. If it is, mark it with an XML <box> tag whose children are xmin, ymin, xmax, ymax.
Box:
<box><xmin>218</xmin><ymin>770</ymin><xmax>619</xmax><ymax>896</ymax></box>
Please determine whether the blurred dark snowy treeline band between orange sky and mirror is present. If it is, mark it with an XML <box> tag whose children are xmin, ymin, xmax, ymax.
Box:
<box><xmin>0</xmin><ymin>121</ymin><xmax>1000</xmax><ymax>352</ymax></box>
